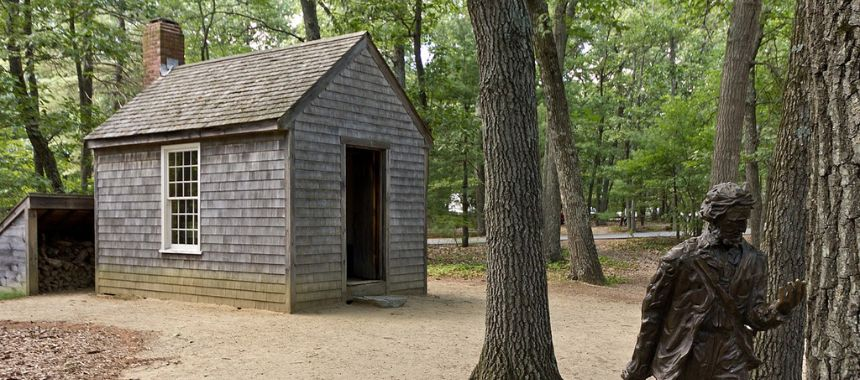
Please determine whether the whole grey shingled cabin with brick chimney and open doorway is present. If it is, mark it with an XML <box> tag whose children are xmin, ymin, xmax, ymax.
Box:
<box><xmin>86</xmin><ymin>19</ymin><xmax>431</xmax><ymax>312</ymax></box>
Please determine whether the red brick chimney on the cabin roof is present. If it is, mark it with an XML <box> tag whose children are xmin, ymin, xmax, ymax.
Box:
<box><xmin>143</xmin><ymin>18</ymin><xmax>185</xmax><ymax>88</ymax></box>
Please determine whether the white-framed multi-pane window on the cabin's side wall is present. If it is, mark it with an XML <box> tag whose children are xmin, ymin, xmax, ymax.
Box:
<box><xmin>161</xmin><ymin>143</ymin><xmax>200</xmax><ymax>255</ymax></box>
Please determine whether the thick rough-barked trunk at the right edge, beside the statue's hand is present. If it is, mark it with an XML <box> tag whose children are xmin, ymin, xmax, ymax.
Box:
<box><xmin>795</xmin><ymin>0</ymin><xmax>860</xmax><ymax>380</ymax></box>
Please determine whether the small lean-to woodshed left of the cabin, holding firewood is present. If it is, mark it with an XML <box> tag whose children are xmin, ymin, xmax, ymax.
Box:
<box><xmin>0</xmin><ymin>194</ymin><xmax>94</xmax><ymax>295</ymax></box>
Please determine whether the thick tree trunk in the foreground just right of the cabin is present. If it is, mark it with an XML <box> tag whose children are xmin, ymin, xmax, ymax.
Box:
<box><xmin>468</xmin><ymin>0</ymin><xmax>561</xmax><ymax>379</ymax></box>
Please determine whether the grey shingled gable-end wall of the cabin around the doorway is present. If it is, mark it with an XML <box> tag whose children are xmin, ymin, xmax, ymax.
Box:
<box><xmin>291</xmin><ymin>51</ymin><xmax>427</xmax><ymax>307</ymax></box>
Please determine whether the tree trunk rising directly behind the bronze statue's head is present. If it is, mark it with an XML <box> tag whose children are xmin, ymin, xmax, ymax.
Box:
<box><xmin>711</xmin><ymin>0</ymin><xmax>761</xmax><ymax>186</ymax></box>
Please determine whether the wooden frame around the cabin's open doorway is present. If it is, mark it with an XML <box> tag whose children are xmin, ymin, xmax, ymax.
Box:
<box><xmin>340</xmin><ymin>137</ymin><xmax>390</xmax><ymax>298</ymax></box>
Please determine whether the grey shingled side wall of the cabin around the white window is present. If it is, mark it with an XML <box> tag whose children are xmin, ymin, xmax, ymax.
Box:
<box><xmin>96</xmin><ymin>135</ymin><xmax>286</xmax><ymax>310</ymax></box>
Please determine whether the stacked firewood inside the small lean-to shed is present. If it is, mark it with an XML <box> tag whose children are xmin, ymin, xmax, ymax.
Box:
<box><xmin>39</xmin><ymin>239</ymin><xmax>95</xmax><ymax>292</ymax></box>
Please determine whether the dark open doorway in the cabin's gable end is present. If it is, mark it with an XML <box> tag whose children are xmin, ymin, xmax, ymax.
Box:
<box><xmin>346</xmin><ymin>147</ymin><xmax>383</xmax><ymax>281</ymax></box>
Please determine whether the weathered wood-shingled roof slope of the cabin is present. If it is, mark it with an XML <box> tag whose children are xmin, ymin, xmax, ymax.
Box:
<box><xmin>86</xmin><ymin>32</ymin><xmax>372</xmax><ymax>142</ymax></box>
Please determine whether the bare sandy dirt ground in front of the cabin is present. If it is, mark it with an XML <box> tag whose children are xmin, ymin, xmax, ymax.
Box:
<box><xmin>0</xmin><ymin>280</ymin><xmax>644</xmax><ymax>380</ymax></box>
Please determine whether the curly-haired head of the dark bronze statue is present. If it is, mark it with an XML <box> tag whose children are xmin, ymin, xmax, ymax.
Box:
<box><xmin>699</xmin><ymin>182</ymin><xmax>755</xmax><ymax>244</ymax></box>
